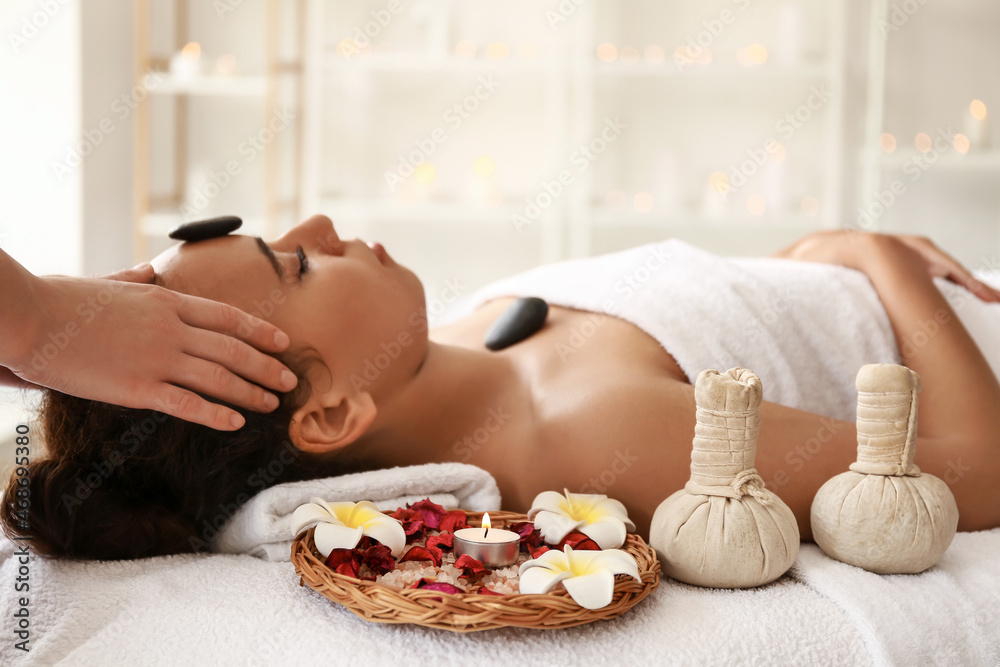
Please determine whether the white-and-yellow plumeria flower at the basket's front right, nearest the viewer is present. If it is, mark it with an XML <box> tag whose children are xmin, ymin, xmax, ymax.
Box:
<box><xmin>518</xmin><ymin>546</ymin><xmax>642</xmax><ymax>609</ymax></box>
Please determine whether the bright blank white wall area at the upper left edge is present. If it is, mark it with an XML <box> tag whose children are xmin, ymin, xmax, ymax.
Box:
<box><xmin>0</xmin><ymin>0</ymin><xmax>82</xmax><ymax>274</ymax></box>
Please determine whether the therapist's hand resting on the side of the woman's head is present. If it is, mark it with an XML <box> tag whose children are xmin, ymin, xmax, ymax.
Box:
<box><xmin>9</xmin><ymin>264</ymin><xmax>298</xmax><ymax>431</ymax></box>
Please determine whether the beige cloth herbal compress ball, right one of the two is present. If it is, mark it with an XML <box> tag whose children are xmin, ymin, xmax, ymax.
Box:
<box><xmin>810</xmin><ymin>364</ymin><xmax>958</xmax><ymax>574</ymax></box>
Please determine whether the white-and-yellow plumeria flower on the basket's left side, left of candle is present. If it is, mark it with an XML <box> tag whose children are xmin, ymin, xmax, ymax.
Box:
<box><xmin>292</xmin><ymin>498</ymin><xmax>406</xmax><ymax>558</ymax></box>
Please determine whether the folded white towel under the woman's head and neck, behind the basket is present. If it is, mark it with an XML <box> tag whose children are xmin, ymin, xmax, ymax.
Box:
<box><xmin>212</xmin><ymin>463</ymin><xmax>500</xmax><ymax>561</ymax></box>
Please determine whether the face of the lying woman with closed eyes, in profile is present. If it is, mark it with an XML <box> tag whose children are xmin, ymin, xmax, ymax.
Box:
<box><xmin>152</xmin><ymin>215</ymin><xmax>427</xmax><ymax>396</ymax></box>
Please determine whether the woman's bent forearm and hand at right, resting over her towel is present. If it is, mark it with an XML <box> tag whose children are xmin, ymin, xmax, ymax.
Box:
<box><xmin>761</xmin><ymin>231</ymin><xmax>1000</xmax><ymax>530</ymax></box>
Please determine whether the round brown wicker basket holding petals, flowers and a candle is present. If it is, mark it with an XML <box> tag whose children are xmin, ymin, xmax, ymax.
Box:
<box><xmin>292</xmin><ymin>512</ymin><xmax>660</xmax><ymax>632</ymax></box>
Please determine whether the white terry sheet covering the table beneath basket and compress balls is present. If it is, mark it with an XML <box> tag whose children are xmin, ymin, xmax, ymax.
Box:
<box><xmin>0</xmin><ymin>529</ymin><xmax>1000</xmax><ymax>667</ymax></box>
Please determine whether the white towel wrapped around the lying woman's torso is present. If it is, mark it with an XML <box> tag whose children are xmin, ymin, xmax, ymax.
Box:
<box><xmin>467</xmin><ymin>239</ymin><xmax>1000</xmax><ymax>421</ymax></box>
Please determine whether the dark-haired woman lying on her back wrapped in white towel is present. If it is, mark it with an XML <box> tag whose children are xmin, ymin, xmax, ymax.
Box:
<box><xmin>2</xmin><ymin>216</ymin><xmax>1000</xmax><ymax>559</ymax></box>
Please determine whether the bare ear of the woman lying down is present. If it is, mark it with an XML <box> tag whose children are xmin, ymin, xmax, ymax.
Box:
<box><xmin>288</xmin><ymin>391</ymin><xmax>378</xmax><ymax>454</ymax></box>
